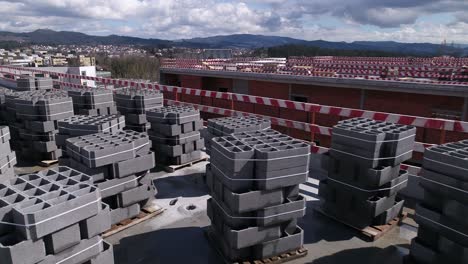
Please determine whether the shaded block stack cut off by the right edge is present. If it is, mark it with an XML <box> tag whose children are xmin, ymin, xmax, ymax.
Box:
<box><xmin>410</xmin><ymin>140</ymin><xmax>468</xmax><ymax>264</ymax></box>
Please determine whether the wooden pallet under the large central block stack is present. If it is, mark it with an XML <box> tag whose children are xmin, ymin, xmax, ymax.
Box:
<box><xmin>203</xmin><ymin>227</ymin><xmax>308</xmax><ymax>264</ymax></box>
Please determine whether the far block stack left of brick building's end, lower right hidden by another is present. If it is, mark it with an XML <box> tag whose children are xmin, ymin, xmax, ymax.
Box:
<box><xmin>114</xmin><ymin>88</ymin><xmax>163</xmax><ymax>132</ymax></box>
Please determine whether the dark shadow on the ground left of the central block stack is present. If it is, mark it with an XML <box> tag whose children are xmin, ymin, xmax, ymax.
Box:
<box><xmin>114</xmin><ymin>227</ymin><xmax>222</xmax><ymax>264</ymax></box>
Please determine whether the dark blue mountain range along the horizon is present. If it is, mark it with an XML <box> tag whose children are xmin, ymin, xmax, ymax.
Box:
<box><xmin>0</xmin><ymin>29</ymin><xmax>468</xmax><ymax>56</ymax></box>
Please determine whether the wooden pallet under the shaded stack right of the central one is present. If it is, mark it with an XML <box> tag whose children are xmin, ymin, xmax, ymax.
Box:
<box><xmin>314</xmin><ymin>207</ymin><xmax>408</xmax><ymax>241</ymax></box>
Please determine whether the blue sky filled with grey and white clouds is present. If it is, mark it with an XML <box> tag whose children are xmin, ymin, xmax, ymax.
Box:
<box><xmin>0</xmin><ymin>0</ymin><xmax>468</xmax><ymax>44</ymax></box>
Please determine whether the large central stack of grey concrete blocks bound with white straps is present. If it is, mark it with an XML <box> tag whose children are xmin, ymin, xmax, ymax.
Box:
<box><xmin>206</xmin><ymin>129</ymin><xmax>310</xmax><ymax>262</ymax></box>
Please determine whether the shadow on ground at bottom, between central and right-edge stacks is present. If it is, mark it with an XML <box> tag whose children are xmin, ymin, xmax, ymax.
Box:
<box><xmin>308</xmin><ymin>245</ymin><xmax>408</xmax><ymax>264</ymax></box>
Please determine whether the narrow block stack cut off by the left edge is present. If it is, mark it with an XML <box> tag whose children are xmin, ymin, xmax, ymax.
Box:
<box><xmin>0</xmin><ymin>126</ymin><xmax>16</xmax><ymax>183</ymax></box>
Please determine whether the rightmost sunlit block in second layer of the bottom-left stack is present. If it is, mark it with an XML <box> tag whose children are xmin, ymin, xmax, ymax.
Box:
<box><xmin>79</xmin><ymin>203</ymin><xmax>112</xmax><ymax>239</ymax></box>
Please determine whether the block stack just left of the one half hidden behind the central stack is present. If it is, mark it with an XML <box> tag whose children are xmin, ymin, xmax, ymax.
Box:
<box><xmin>146</xmin><ymin>106</ymin><xmax>205</xmax><ymax>165</ymax></box>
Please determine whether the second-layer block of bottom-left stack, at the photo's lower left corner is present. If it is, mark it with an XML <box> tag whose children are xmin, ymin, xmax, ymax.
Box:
<box><xmin>0</xmin><ymin>233</ymin><xmax>46</xmax><ymax>264</ymax></box>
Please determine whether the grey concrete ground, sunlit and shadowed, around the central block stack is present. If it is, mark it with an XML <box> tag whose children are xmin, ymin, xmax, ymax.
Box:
<box><xmin>106</xmin><ymin>159</ymin><xmax>417</xmax><ymax>264</ymax></box>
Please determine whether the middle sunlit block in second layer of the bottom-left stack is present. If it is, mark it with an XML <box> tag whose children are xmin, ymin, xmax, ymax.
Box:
<box><xmin>44</xmin><ymin>224</ymin><xmax>81</xmax><ymax>255</ymax></box>
